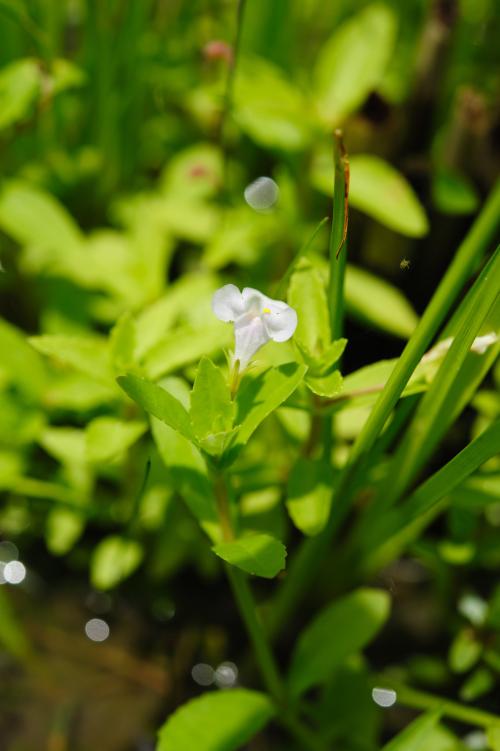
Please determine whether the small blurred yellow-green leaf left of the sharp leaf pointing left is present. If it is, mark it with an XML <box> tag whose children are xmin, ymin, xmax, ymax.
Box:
<box><xmin>85</xmin><ymin>417</ymin><xmax>147</xmax><ymax>462</ymax></box>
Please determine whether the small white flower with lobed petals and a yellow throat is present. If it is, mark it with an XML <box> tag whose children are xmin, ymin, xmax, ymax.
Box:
<box><xmin>212</xmin><ymin>284</ymin><xmax>297</xmax><ymax>371</ymax></box>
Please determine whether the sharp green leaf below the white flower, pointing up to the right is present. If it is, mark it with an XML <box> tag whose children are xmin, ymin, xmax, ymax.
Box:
<box><xmin>236</xmin><ymin>362</ymin><xmax>307</xmax><ymax>446</ymax></box>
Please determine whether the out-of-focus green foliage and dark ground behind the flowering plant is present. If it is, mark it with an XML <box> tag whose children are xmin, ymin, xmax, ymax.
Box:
<box><xmin>0</xmin><ymin>0</ymin><xmax>500</xmax><ymax>751</ymax></box>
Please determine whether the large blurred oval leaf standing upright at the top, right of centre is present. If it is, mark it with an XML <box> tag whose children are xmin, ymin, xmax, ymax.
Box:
<box><xmin>314</xmin><ymin>3</ymin><xmax>396</xmax><ymax>127</ymax></box>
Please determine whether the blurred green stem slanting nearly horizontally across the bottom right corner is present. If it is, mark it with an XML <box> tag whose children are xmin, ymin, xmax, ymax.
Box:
<box><xmin>378</xmin><ymin>676</ymin><xmax>500</xmax><ymax>728</ymax></box>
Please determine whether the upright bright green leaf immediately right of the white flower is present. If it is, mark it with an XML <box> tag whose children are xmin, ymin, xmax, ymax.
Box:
<box><xmin>288</xmin><ymin>259</ymin><xmax>331</xmax><ymax>358</ymax></box>
